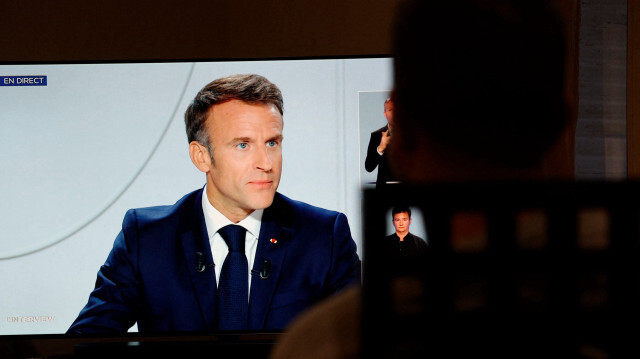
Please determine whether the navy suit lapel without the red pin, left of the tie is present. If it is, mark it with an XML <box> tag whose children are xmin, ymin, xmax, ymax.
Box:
<box><xmin>180</xmin><ymin>190</ymin><xmax>217</xmax><ymax>330</ymax></box>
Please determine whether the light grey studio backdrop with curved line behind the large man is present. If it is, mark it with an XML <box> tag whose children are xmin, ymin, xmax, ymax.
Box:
<box><xmin>0</xmin><ymin>58</ymin><xmax>392</xmax><ymax>334</ymax></box>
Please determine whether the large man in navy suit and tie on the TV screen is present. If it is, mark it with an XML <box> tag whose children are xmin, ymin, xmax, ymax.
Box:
<box><xmin>68</xmin><ymin>75</ymin><xmax>360</xmax><ymax>333</ymax></box>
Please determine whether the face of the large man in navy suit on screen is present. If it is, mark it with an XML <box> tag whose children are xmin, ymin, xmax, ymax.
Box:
<box><xmin>206</xmin><ymin>100</ymin><xmax>282</xmax><ymax>222</ymax></box>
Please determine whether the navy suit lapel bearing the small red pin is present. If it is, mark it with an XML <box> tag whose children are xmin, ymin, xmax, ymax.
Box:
<box><xmin>249</xmin><ymin>193</ymin><xmax>291</xmax><ymax>330</ymax></box>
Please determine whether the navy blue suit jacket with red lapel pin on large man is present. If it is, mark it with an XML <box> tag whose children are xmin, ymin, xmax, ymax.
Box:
<box><xmin>68</xmin><ymin>189</ymin><xmax>361</xmax><ymax>333</ymax></box>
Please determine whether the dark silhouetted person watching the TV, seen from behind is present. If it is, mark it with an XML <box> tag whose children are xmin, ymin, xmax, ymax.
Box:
<box><xmin>271</xmin><ymin>0</ymin><xmax>573</xmax><ymax>359</ymax></box>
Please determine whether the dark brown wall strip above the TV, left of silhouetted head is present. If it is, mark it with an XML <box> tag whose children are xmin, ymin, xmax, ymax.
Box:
<box><xmin>0</xmin><ymin>0</ymin><xmax>399</xmax><ymax>63</ymax></box>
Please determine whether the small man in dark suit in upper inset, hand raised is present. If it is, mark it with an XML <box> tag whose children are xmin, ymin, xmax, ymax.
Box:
<box><xmin>364</xmin><ymin>98</ymin><xmax>394</xmax><ymax>187</ymax></box>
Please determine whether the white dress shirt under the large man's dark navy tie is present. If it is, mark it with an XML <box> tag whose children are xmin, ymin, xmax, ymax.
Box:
<box><xmin>202</xmin><ymin>186</ymin><xmax>264</xmax><ymax>300</ymax></box>
